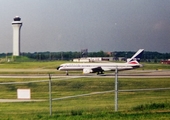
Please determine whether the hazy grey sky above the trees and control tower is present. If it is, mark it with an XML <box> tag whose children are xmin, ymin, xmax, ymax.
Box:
<box><xmin>0</xmin><ymin>0</ymin><xmax>170</xmax><ymax>53</ymax></box>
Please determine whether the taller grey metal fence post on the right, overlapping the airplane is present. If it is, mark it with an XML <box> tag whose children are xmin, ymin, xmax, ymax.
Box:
<box><xmin>115</xmin><ymin>66</ymin><xmax>118</xmax><ymax>112</ymax></box>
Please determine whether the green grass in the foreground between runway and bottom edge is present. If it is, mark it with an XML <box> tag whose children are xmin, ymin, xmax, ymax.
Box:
<box><xmin>0</xmin><ymin>77</ymin><xmax>170</xmax><ymax>120</ymax></box>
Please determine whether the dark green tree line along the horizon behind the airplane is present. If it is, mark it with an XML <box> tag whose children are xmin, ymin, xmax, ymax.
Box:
<box><xmin>0</xmin><ymin>51</ymin><xmax>170</xmax><ymax>62</ymax></box>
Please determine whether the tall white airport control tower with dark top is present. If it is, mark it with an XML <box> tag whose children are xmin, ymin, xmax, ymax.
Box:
<box><xmin>12</xmin><ymin>16</ymin><xmax>22</xmax><ymax>56</ymax></box>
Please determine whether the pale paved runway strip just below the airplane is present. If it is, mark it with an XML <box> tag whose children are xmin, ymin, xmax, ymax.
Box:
<box><xmin>0</xmin><ymin>70</ymin><xmax>170</xmax><ymax>78</ymax></box>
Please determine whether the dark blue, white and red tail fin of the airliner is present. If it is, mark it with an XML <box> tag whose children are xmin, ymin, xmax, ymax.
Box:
<box><xmin>127</xmin><ymin>49</ymin><xmax>144</xmax><ymax>64</ymax></box>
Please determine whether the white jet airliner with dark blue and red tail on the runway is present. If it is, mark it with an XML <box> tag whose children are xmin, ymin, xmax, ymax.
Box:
<box><xmin>57</xmin><ymin>49</ymin><xmax>144</xmax><ymax>75</ymax></box>
